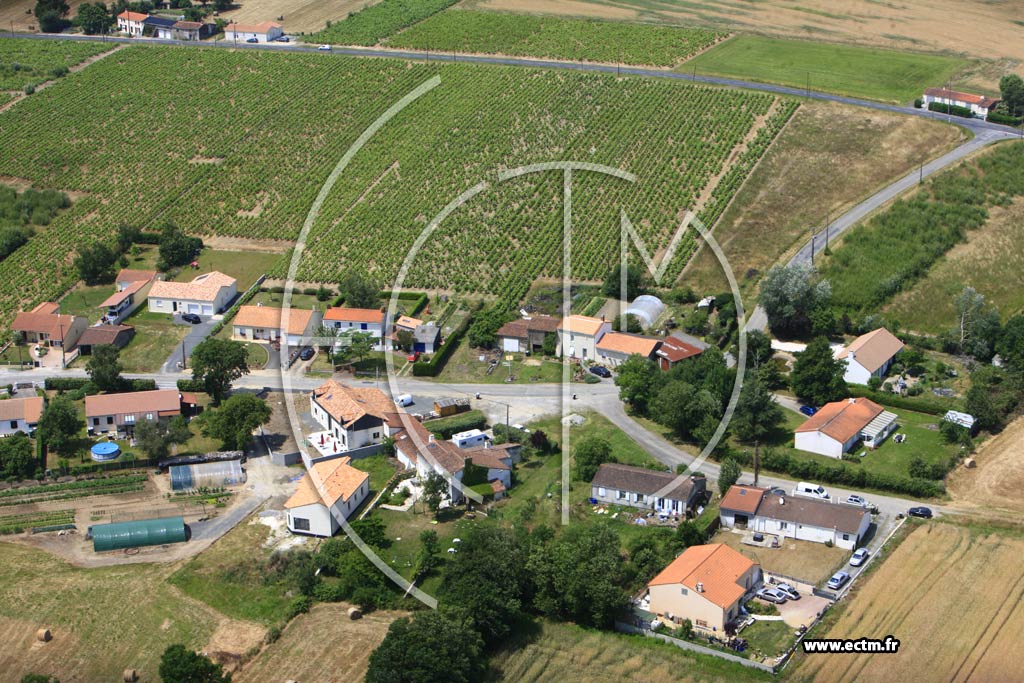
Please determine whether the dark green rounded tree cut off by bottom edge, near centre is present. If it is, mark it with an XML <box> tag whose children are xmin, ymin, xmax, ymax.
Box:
<box><xmin>366</xmin><ymin>610</ymin><xmax>486</xmax><ymax>683</ymax></box>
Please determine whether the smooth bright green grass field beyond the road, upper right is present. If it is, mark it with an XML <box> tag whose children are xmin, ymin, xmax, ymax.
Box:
<box><xmin>679</xmin><ymin>35</ymin><xmax>967</xmax><ymax>102</ymax></box>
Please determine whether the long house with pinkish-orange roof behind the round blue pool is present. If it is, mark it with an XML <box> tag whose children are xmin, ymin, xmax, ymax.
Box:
<box><xmin>85</xmin><ymin>389</ymin><xmax>197</xmax><ymax>435</ymax></box>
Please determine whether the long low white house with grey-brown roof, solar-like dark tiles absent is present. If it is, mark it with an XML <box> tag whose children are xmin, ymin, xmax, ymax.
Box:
<box><xmin>590</xmin><ymin>463</ymin><xmax>707</xmax><ymax>516</ymax></box>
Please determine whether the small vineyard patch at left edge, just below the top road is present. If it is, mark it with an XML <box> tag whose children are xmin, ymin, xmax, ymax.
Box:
<box><xmin>0</xmin><ymin>40</ymin><xmax>110</xmax><ymax>91</ymax></box>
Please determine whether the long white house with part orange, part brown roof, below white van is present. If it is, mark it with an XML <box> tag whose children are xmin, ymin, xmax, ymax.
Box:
<box><xmin>719</xmin><ymin>485</ymin><xmax>871</xmax><ymax>550</ymax></box>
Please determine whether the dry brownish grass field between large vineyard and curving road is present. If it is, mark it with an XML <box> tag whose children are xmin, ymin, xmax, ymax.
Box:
<box><xmin>683</xmin><ymin>102</ymin><xmax>964</xmax><ymax>301</ymax></box>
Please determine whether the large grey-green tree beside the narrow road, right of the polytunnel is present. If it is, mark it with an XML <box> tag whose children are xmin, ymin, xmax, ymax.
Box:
<box><xmin>760</xmin><ymin>263</ymin><xmax>831</xmax><ymax>337</ymax></box>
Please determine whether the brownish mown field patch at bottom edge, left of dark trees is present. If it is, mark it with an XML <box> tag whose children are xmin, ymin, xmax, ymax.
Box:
<box><xmin>233</xmin><ymin>603</ymin><xmax>404</xmax><ymax>683</ymax></box>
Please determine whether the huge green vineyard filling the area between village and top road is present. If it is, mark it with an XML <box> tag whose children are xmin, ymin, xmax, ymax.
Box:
<box><xmin>0</xmin><ymin>41</ymin><xmax>796</xmax><ymax>315</ymax></box>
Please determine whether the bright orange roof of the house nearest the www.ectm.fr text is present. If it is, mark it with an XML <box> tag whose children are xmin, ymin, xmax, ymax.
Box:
<box><xmin>648</xmin><ymin>543</ymin><xmax>757</xmax><ymax>609</ymax></box>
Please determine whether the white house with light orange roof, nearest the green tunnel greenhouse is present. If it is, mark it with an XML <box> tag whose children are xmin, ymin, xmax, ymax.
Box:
<box><xmin>285</xmin><ymin>456</ymin><xmax>370</xmax><ymax>538</ymax></box>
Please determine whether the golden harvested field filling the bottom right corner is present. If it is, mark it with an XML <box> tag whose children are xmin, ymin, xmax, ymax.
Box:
<box><xmin>791</xmin><ymin>523</ymin><xmax>1024</xmax><ymax>683</ymax></box>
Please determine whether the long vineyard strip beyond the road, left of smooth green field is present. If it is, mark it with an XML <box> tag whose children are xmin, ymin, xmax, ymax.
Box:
<box><xmin>385</xmin><ymin>10</ymin><xmax>725</xmax><ymax>67</ymax></box>
